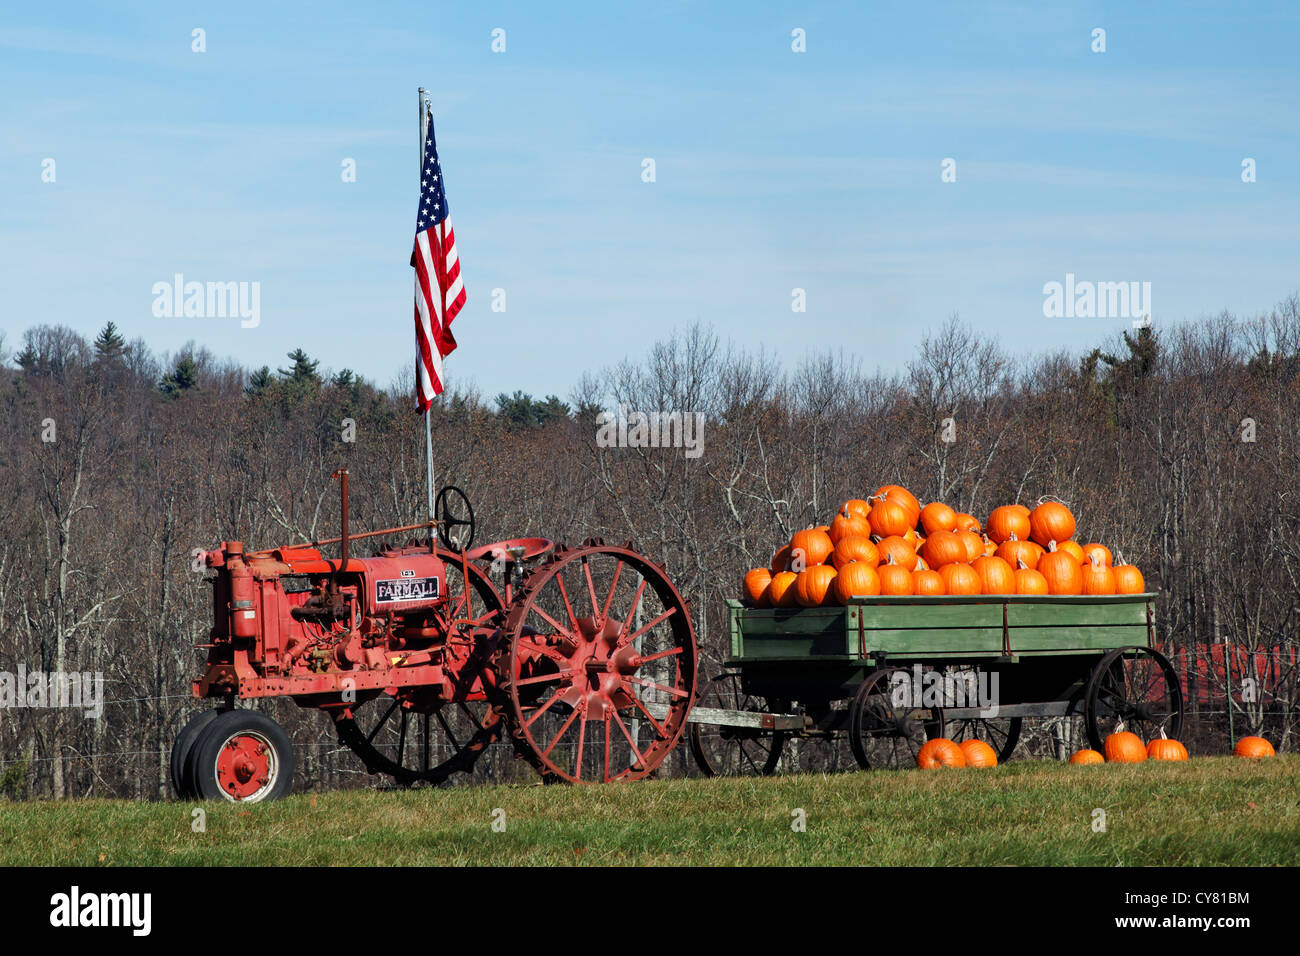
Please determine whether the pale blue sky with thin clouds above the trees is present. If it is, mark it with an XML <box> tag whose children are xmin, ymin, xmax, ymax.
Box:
<box><xmin>0</xmin><ymin>3</ymin><xmax>1300</xmax><ymax>395</ymax></box>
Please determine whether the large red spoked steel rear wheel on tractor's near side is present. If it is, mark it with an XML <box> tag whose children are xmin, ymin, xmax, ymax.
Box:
<box><xmin>494</xmin><ymin>540</ymin><xmax>696</xmax><ymax>783</ymax></box>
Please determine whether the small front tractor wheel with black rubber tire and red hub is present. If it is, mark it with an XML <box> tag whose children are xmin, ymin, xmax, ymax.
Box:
<box><xmin>186</xmin><ymin>710</ymin><xmax>294</xmax><ymax>804</ymax></box>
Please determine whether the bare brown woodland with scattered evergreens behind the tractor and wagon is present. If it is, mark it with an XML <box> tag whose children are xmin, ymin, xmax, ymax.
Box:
<box><xmin>0</xmin><ymin>297</ymin><xmax>1300</xmax><ymax>797</ymax></box>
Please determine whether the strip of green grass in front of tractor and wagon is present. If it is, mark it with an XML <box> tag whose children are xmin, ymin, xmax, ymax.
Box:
<box><xmin>0</xmin><ymin>756</ymin><xmax>1300</xmax><ymax>866</ymax></box>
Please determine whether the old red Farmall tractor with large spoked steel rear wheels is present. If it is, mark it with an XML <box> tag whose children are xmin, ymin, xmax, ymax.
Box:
<box><xmin>172</xmin><ymin>472</ymin><xmax>697</xmax><ymax>803</ymax></box>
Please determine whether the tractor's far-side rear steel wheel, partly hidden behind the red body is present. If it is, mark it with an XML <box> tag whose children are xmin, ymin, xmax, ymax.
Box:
<box><xmin>334</xmin><ymin>545</ymin><xmax>502</xmax><ymax>787</ymax></box>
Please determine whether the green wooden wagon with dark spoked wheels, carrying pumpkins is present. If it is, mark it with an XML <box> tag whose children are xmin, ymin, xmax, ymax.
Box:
<box><xmin>689</xmin><ymin>593</ymin><xmax>1183</xmax><ymax>774</ymax></box>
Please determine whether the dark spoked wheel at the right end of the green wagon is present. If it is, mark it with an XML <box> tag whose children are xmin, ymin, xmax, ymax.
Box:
<box><xmin>1083</xmin><ymin>645</ymin><xmax>1183</xmax><ymax>750</ymax></box>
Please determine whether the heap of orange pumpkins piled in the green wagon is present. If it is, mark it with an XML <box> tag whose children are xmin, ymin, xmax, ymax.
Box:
<box><xmin>742</xmin><ymin>485</ymin><xmax>1145</xmax><ymax>607</ymax></box>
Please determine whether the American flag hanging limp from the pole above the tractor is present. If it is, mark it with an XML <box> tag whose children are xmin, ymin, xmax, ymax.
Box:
<box><xmin>411</xmin><ymin>114</ymin><xmax>465</xmax><ymax>412</ymax></box>
